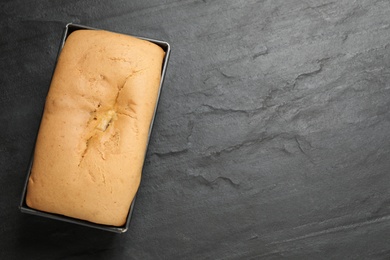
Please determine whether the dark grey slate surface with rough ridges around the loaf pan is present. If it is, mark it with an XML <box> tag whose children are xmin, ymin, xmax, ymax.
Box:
<box><xmin>0</xmin><ymin>0</ymin><xmax>390</xmax><ymax>259</ymax></box>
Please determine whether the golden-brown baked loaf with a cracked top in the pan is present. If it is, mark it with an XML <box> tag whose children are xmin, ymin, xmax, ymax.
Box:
<box><xmin>26</xmin><ymin>30</ymin><xmax>165</xmax><ymax>226</ymax></box>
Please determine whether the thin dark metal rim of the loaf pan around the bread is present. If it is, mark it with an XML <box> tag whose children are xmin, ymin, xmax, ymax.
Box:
<box><xmin>19</xmin><ymin>23</ymin><xmax>171</xmax><ymax>233</ymax></box>
